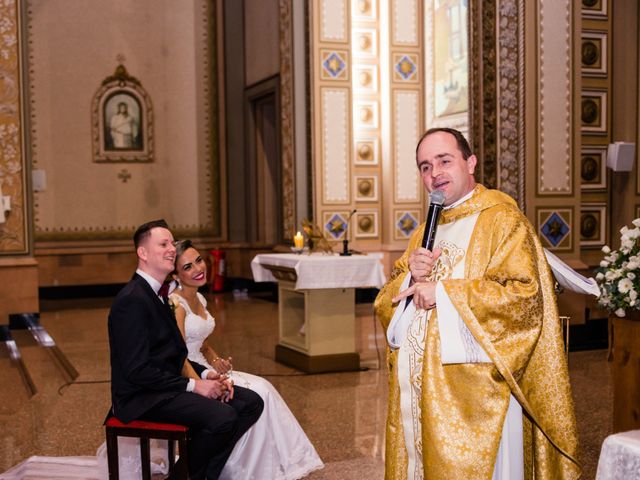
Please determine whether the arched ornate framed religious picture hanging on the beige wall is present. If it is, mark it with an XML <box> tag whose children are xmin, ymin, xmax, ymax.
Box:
<box><xmin>92</xmin><ymin>65</ymin><xmax>154</xmax><ymax>163</ymax></box>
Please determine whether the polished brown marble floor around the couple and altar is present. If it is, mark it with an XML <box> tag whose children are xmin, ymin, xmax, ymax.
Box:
<box><xmin>0</xmin><ymin>293</ymin><xmax>612</xmax><ymax>480</ymax></box>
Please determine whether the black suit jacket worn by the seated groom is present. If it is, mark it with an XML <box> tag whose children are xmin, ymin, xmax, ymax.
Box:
<box><xmin>109</xmin><ymin>274</ymin><xmax>205</xmax><ymax>422</ymax></box>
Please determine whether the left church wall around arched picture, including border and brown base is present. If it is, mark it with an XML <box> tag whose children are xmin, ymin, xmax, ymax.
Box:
<box><xmin>18</xmin><ymin>0</ymin><xmax>226</xmax><ymax>286</ymax></box>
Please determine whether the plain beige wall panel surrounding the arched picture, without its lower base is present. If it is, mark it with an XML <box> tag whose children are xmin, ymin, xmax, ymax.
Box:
<box><xmin>28</xmin><ymin>0</ymin><xmax>219</xmax><ymax>238</ymax></box>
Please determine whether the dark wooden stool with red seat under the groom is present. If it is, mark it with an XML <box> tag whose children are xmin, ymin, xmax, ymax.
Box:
<box><xmin>105</xmin><ymin>416</ymin><xmax>189</xmax><ymax>480</ymax></box>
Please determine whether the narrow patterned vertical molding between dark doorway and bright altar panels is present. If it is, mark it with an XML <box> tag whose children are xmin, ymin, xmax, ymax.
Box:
<box><xmin>279</xmin><ymin>0</ymin><xmax>296</xmax><ymax>238</ymax></box>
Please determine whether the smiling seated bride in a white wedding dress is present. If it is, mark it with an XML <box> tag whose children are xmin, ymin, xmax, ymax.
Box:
<box><xmin>170</xmin><ymin>240</ymin><xmax>324</xmax><ymax>480</ymax></box>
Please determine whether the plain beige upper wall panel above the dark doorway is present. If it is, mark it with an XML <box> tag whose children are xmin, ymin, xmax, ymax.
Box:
<box><xmin>244</xmin><ymin>0</ymin><xmax>280</xmax><ymax>85</ymax></box>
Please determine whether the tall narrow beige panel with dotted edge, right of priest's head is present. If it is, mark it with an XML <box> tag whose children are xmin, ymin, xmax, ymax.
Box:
<box><xmin>538</xmin><ymin>0</ymin><xmax>572</xmax><ymax>194</ymax></box>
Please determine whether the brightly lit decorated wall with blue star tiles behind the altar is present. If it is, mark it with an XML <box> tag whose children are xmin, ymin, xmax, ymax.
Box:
<box><xmin>309</xmin><ymin>0</ymin><xmax>427</xmax><ymax>278</ymax></box>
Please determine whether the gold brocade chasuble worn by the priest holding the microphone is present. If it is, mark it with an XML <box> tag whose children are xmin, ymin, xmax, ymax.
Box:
<box><xmin>375</xmin><ymin>185</ymin><xmax>580</xmax><ymax>480</ymax></box>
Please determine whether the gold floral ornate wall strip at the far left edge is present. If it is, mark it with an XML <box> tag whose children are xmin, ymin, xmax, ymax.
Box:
<box><xmin>0</xmin><ymin>0</ymin><xmax>30</xmax><ymax>255</ymax></box>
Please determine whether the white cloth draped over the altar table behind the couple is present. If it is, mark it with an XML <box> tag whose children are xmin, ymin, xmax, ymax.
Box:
<box><xmin>251</xmin><ymin>253</ymin><xmax>386</xmax><ymax>290</ymax></box>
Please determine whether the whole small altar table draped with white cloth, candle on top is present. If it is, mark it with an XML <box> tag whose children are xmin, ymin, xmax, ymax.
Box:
<box><xmin>251</xmin><ymin>253</ymin><xmax>386</xmax><ymax>373</ymax></box>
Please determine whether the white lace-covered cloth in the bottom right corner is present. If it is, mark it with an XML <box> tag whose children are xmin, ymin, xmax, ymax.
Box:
<box><xmin>596</xmin><ymin>430</ymin><xmax>640</xmax><ymax>480</ymax></box>
